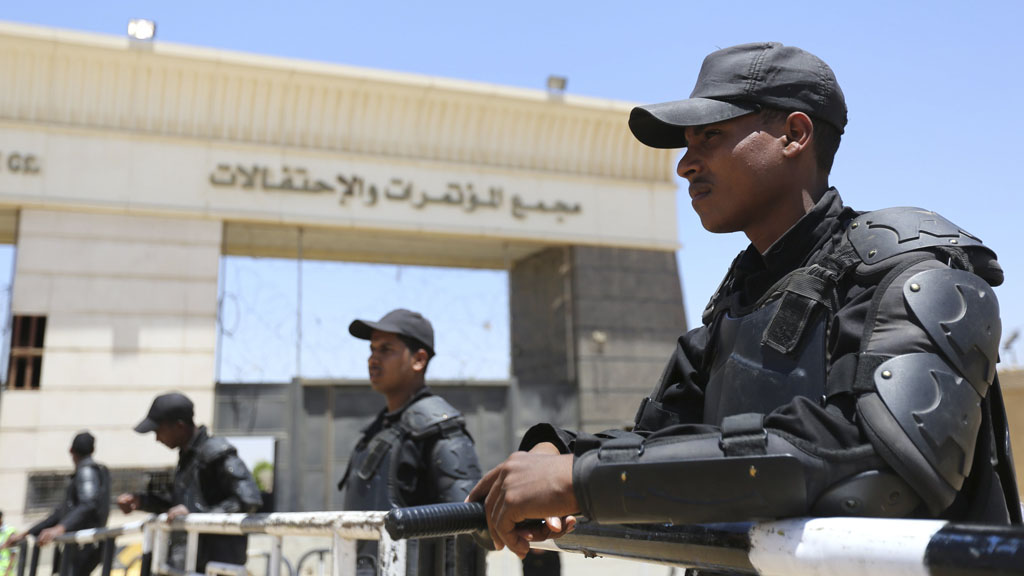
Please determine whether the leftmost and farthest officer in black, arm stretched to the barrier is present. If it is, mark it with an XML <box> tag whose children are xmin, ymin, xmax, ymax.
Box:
<box><xmin>4</xmin><ymin>431</ymin><xmax>111</xmax><ymax>576</ymax></box>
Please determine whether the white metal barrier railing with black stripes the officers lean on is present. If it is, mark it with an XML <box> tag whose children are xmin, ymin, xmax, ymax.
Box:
<box><xmin>18</xmin><ymin>504</ymin><xmax>1024</xmax><ymax>576</ymax></box>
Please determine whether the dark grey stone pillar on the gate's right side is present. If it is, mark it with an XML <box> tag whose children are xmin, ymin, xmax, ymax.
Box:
<box><xmin>509</xmin><ymin>246</ymin><xmax>686</xmax><ymax>435</ymax></box>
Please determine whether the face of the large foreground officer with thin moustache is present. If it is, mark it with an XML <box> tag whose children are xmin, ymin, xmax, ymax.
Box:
<box><xmin>677</xmin><ymin>114</ymin><xmax>795</xmax><ymax>244</ymax></box>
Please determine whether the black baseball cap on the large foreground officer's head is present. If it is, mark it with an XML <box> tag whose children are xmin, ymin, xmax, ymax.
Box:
<box><xmin>630</xmin><ymin>42</ymin><xmax>847</xmax><ymax>149</ymax></box>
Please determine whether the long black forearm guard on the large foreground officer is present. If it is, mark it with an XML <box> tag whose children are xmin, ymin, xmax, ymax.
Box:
<box><xmin>572</xmin><ymin>414</ymin><xmax>919</xmax><ymax>524</ymax></box>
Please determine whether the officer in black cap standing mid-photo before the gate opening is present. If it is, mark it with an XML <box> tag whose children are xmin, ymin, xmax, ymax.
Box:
<box><xmin>338</xmin><ymin>308</ymin><xmax>484</xmax><ymax>576</ymax></box>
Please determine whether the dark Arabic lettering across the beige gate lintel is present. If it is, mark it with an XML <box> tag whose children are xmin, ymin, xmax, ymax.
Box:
<box><xmin>209</xmin><ymin>164</ymin><xmax>583</xmax><ymax>221</ymax></box>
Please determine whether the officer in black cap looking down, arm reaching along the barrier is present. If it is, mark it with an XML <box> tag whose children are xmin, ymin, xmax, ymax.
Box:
<box><xmin>118</xmin><ymin>394</ymin><xmax>262</xmax><ymax>572</ymax></box>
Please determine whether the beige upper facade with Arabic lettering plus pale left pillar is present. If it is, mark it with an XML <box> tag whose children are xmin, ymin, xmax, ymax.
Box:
<box><xmin>0</xmin><ymin>24</ymin><xmax>682</xmax><ymax>524</ymax></box>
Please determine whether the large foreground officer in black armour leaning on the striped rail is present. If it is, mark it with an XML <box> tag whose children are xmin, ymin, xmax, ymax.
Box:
<box><xmin>470</xmin><ymin>43</ymin><xmax>1021</xmax><ymax>556</ymax></box>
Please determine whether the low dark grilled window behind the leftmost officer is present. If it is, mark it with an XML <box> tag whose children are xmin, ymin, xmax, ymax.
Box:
<box><xmin>25</xmin><ymin>468</ymin><xmax>174</xmax><ymax>513</ymax></box>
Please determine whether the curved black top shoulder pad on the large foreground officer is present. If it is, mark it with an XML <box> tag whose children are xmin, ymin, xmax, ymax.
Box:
<box><xmin>848</xmin><ymin>208</ymin><xmax>995</xmax><ymax>264</ymax></box>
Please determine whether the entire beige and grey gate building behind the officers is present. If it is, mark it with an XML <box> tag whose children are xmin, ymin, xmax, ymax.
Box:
<box><xmin>0</xmin><ymin>24</ymin><xmax>686</xmax><ymax>523</ymax></box>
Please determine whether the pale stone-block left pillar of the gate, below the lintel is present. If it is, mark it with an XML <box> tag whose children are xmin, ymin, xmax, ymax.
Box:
<box><xmin>0</xmin><ymin>209</ymin><xmax>221</xmax><ymax>520</ymax></box>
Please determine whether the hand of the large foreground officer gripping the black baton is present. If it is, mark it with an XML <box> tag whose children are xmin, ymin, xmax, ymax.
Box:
<box><xmin>466</xmin><ymin>445</ymin><xmax>580</xmax><ymax>558</ymax></box>
